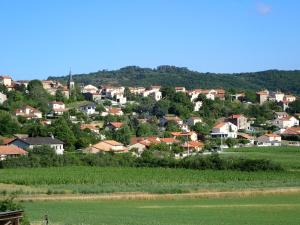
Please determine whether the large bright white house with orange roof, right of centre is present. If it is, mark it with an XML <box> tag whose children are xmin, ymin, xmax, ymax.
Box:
<box><xmin>211</xmin><ymin>122</ymin><xmax>238</xmax><ymax>138</ymax></box>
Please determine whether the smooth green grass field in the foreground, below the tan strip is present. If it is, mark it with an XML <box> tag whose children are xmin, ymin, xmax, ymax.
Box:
<box><xmin>23</xmin><ymin>194</ymin><xmax>300</xmax><ymax>225</ymax></box>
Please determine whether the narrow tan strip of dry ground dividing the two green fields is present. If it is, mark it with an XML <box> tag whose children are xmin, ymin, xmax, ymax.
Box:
<box><xmin>6</xmin><ymin>187</ymin><xmax>300</xmax><ymax>201</ymax></box>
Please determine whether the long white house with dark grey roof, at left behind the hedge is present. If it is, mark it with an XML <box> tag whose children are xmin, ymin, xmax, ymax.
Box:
<box><xmin>9</xmin><ymin>137</ymin><xmax>64</xmax><ymax>155</ymax></box>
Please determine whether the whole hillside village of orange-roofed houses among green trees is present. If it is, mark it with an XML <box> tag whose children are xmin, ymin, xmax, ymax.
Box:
<box><xmin>0</xmin><ymin>73</ymin><xmax>300</xmax><ymax>160</ymax></box>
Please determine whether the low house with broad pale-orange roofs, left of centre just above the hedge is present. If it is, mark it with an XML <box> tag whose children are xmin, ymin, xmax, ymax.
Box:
<box><xmin>84</xmin><ymin>140</ymin><xmax>128</xmax><ymax>153</ymax></box>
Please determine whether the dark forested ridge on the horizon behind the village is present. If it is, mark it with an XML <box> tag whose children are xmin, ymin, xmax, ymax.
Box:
<box><xmin>48</xmin><ymin>66</ymin><xmax>300</xmax><ymax>94</ymax></box>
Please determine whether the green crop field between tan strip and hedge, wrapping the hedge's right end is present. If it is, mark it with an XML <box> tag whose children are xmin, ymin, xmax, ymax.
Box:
<box><xmin>0</xmin><ymin>147</ymin><xmax>300</xmax><ymax>194</ymax></box>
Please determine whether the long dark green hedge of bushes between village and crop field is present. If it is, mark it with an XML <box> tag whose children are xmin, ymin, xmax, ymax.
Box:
<box><xmin>0</xmin><ymin>146</ymin><xmax>283</xmax><ymax>171</ymax></box>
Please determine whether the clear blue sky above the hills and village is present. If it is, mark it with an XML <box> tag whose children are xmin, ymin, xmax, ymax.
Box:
<box><xmin>0</xmin><ymin>0</ymin><xmax>300</xmax><ymax>79</ymax></box>
